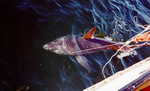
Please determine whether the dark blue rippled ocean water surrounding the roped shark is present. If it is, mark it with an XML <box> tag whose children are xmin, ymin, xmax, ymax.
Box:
<box><xmin>0</xmin><ymin>0</ymin><xmax>150</xmax><ymax>91</ymax></box>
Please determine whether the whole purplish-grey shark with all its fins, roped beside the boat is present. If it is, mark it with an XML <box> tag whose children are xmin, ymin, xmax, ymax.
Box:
<box><xmin>43</xmin><ymin>27</ymin><xmax>149</xmax><ymax>72</ymax></box>
